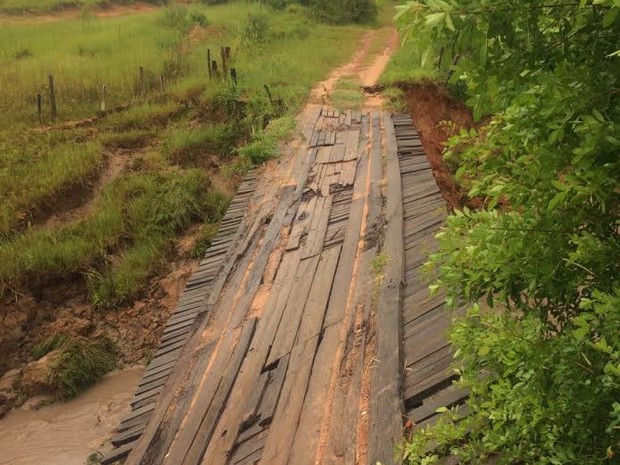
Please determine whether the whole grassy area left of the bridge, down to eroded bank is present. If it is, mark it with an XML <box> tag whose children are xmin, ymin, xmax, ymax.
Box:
<box><xmin>0</xmin><ymin>2</ymin><xmax>363</xmax><ymax>308</ymax></box>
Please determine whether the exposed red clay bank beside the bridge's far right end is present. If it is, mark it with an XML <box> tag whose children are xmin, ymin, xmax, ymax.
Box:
<box><xmin>403</xmin><ymin>83</ymin><xmax>477</xmax><ymax>209</ymax></box>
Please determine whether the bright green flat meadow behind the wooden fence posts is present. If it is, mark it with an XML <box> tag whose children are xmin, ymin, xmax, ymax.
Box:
<box><xmin>0</xmin><ymin>3</ymin><xmax>361</xmax><ymax>126</ymax></box>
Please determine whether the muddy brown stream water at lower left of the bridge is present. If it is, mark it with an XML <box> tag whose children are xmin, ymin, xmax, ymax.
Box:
<box><xmin>0</xmin><ymin>367</ymin><xmax>144</xmax><ymax>465</ymax></box>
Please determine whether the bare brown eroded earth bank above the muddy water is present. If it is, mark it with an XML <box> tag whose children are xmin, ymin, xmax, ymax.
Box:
<box><xmin>0</xmin><ymin>227</ymin><xmax>199</xmax><ymax>416</ymax></box>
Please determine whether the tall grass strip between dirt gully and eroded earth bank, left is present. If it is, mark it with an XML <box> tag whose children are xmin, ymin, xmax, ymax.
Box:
<box><xmin>0</xmin><ymin>170</ymin><xmax>209</xmax><ymax>294</ymax></box>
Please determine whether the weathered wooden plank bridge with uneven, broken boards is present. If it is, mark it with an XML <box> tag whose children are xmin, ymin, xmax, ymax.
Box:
<box><xmin>101</xmin><ymin>106</ymin><xmax>466</xmax><ymax>465</ymax></box>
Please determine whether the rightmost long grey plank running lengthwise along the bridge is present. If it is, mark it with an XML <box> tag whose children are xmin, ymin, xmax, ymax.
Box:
<box><xmin>368</xmin><ymin>113</ymin><xmax>404</xmax><ymax>465</ymax></box>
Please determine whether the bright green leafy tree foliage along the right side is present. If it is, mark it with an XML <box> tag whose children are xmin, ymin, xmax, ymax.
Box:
<box><xmin>398</xmin><ymin>0</ymin><xmax>620</xmax><ymax>464</ymax></box>
